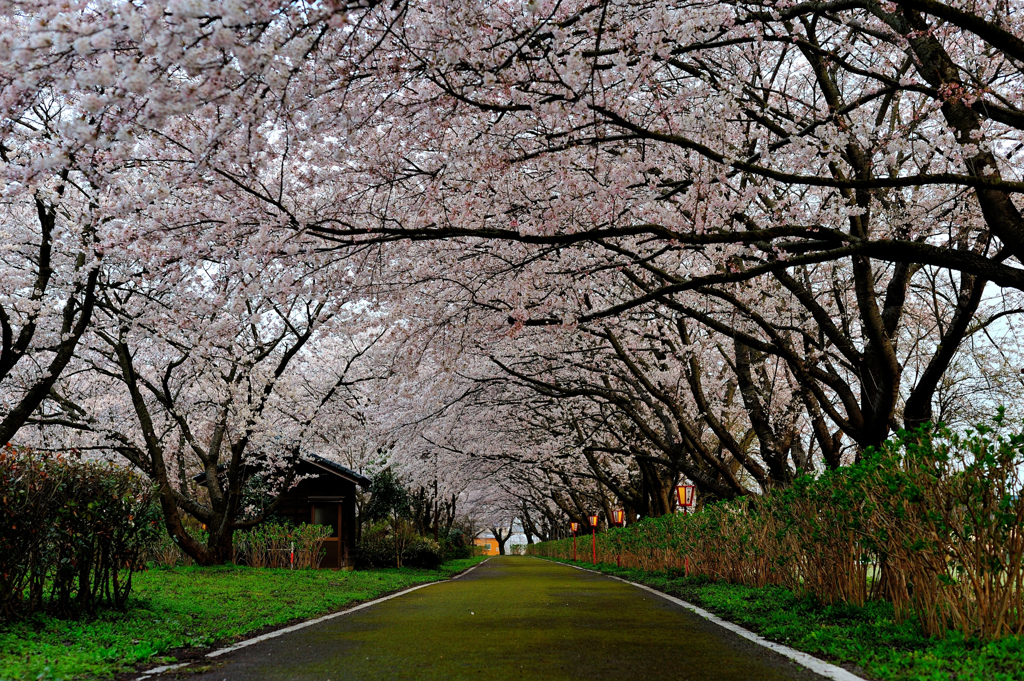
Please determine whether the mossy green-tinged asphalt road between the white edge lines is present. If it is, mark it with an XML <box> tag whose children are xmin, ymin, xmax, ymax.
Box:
<box><xmin>189</xmin><ymin>556</ymin><xmax>821</xmax><ymax>681</ymax></box>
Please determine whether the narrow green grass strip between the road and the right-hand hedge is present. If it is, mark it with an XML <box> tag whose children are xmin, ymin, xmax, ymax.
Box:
<box><xmin>548</xmin><ymin>561</ymin><xmax>1024</xmax><ymax>681</ymax></box>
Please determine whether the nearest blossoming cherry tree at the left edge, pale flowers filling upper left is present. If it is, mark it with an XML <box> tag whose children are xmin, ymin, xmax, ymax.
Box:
<box><xmin>0</xmin><ymin>0</ymin><xmax>387</xmax><ymax>442</ymax></box>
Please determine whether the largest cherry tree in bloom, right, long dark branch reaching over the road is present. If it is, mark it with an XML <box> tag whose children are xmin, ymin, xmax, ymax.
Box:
<box><xmin>311</xmin><ymin>2</ymin><xmax>1020</xmax><ymax>465</ymax></box>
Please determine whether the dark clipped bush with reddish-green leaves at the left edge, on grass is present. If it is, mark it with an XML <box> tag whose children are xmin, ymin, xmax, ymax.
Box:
<box><xmin>0</xmin><ymin>446</ymin><xmax>161</xmax><ymax>619</ymax></box>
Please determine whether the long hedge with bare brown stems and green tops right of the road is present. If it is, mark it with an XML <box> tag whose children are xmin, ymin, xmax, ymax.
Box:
<box><xmin>529</xmin><ymin>413</ymin><xmax>1024</xmax><ymax>640</ymax></box>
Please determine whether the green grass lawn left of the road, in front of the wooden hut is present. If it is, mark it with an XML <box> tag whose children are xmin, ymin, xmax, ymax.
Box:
<box><xmin>0</xmin><ymin>557</ymin><xmax>483</xmax><ymax>681</ymax></box>
